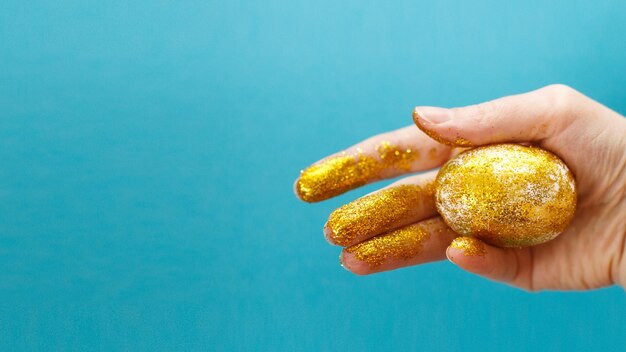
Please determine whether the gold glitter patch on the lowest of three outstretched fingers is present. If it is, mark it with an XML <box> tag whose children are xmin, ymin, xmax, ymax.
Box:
<box><xmin>345</xmin><ymin>224</ymin><xmax>430</xmax><ymax>268</ymax></box>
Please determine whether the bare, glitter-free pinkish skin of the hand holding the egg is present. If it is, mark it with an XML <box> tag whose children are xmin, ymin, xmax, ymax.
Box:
<box><xmin>294</xmin><ymin>85</ymin><xmax>626</xmax><ymax>291</ymax></box>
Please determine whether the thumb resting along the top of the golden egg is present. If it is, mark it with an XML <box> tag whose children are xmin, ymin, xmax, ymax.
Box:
<box><xmin>413</xmin><ymin>85</ymin><xmax>591</xmax><ymax>146</ymax></box>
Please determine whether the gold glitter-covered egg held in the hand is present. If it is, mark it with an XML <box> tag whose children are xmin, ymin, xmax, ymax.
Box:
<box><xmin>435</xmin><ymin>144</ymin><xmax>576</xmax><ymax>247</ymax></box>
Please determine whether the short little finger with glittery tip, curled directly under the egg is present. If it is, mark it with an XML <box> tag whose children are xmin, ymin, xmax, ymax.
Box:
<box><xmin>446</xmin><ymin>237</ymin><xmax>532</xmax><ymax>289</ymax></box>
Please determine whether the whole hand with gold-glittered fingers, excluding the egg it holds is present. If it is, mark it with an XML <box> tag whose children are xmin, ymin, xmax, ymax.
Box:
<box><xmin>296</xmin><ymin>85</ymin><xmax>626</xmax><ymax>291</ymax></box>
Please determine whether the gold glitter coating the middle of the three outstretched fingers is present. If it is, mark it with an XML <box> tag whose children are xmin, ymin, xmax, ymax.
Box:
<box><xmin>326</xmin><ymin>183</ymin><xmax>435</xmax><ymax>246</ymax></box>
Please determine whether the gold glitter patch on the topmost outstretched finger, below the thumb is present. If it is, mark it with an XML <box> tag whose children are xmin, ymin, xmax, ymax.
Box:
<box><xmin>296</xmin><ymin>141</ymin><xmax>419</xmax><ymax>202</ymax></box>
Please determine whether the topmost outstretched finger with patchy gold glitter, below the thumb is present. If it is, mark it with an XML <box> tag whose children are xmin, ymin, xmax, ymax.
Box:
<box><xmin>295</xmin><ymin>126</ymin><xmax>450</xmax><ymax>202</ymax></box>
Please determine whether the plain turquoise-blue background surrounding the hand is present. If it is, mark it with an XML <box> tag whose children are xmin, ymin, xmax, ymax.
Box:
<box><xmin>0</xmin><ymin>0</ymin><xmax>626</xmax><ymax>351</ymax></box>
